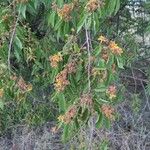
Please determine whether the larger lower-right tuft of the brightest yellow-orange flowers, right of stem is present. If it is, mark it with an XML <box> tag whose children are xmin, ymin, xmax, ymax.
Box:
<box><xmin>108</xmin><ymin>41</ymin><xmax>123</xmax><ymax>55</ymax></box>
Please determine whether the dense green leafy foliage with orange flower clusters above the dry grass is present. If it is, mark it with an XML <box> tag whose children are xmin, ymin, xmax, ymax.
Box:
<box><xmin>0</xmin><ymin>0</ymin><xmax>150</xmax><ymax>148</ymax></box>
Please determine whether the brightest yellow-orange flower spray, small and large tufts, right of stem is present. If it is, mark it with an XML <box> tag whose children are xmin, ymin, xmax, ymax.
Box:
<box><xmin>98</xmin><ymin>36</ymin><xmax>123</xmax><ymax>55</ymax></box>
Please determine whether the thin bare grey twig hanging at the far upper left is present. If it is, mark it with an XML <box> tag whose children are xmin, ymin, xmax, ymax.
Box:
<box><xmin>7</xmin><ymin>15</ymin><xmax>19</xmax><ymax>71</ymax></box>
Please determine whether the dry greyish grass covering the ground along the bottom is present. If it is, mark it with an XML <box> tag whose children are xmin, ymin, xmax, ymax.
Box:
<box><xmin>0</xmin><ymin>86</ymin><xmax>150</xmax><ymax>150</ymax></box>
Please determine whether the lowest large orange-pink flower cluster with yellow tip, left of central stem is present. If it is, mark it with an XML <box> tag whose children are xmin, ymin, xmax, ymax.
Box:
<box><xmin>58</xmin><ymin>106</ymin><xmax>77</xmax><ymax>124</ymax></box>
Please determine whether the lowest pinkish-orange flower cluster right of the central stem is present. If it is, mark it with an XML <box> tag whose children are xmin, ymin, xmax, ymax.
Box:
<box><xmin>101</xmin><ymin>104</ymin><xmax>115</xmax><ymax>120</ymax></box>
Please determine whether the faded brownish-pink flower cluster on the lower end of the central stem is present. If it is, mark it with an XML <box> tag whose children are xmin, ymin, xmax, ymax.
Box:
<box><xmin>80</xmin><ymin>94</ymin><xmax>93</xmax><ymax>106</ymax></box>
